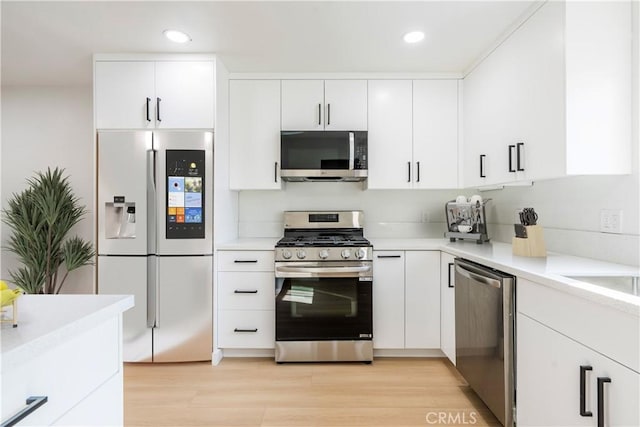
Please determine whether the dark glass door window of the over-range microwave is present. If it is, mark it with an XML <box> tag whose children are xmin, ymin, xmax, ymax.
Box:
<box><xmin>281</xmin><ymin>132</ymin><xmax>349</xmax><ymax>170</ymax></box>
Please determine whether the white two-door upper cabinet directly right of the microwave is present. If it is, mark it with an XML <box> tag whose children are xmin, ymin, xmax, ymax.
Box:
<box><xmin>368</xmin><ymin>80</ymin><xmax>459</xmax><ymax>189</ymax></box>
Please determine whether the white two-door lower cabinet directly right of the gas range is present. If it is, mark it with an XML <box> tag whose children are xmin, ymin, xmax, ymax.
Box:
<box><xmin>373</xmin><ymin>251</ymin><xmax>440</xmax><ymax>349</ymax></box>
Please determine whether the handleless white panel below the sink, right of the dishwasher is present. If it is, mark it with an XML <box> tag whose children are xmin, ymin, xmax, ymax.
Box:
<box><xmin>516</xmin><ymin>278</ymin><xmax>640</xmax><ymax>372</ymax></box>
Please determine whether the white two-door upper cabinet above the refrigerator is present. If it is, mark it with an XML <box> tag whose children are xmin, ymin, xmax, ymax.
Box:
<box><xmin>94</xmin><ymin>61</ymin><xmax>215</xmax><ymax>129</ymax></box>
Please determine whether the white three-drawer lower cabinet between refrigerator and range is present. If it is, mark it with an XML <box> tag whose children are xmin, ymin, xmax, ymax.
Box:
<box><xmin>217</xmin><ymin>251</ymin><xmax>275</xmax><ymax>349</ymax></box>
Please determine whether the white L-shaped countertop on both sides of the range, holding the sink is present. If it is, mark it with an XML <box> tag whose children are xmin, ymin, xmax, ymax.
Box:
<box><xmin>218</xmin><ymin>237</ymin><xmax>640</xmax><ymax>317</ymax></box>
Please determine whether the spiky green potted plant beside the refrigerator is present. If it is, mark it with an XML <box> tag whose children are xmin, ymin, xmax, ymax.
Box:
<box><xmin>2</xmin><ymin>168</ymin><xmax>95</xmax><ymax>294</ymax></box>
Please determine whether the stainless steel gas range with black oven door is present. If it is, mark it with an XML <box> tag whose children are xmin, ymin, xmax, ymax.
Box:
<box><xmin>275</xmin><ymin>211</ymin><xmax>373</xmax><ymax>362</ymax></box>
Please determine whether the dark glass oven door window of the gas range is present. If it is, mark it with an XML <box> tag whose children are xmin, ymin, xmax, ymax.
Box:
<box><xmin>276</xmin><ymin>278</ymin><xmax>372</xmax><ymax>341</ymax></box>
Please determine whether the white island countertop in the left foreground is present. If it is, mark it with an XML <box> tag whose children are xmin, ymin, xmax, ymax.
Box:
<box><xmin>0</xmin><ymin>295</ymin><xmax>134</xmax><ymax>373</ymax></box>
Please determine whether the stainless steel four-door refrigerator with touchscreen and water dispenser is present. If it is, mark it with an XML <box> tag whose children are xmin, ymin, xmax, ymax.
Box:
<box><xmin>97</xmin><ymin>131</ymin><xmax>213</xmax><ymax>362</ymax></box>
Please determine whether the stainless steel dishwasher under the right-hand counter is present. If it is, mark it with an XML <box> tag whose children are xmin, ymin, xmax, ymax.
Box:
<box><xmin>455</xmin><ymin>258</ymin><xmax>515</xmax><ymax>427</ymax></box>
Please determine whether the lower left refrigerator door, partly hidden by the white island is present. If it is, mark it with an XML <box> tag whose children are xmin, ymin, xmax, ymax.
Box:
<box><xmin>98</xmin><ymin>256</ymin><xmax>152</xmax><ymax>362</ymax></box>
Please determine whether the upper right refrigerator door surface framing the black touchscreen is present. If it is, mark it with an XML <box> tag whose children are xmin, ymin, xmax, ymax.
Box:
<box><xmin>153</xmin><ymin>131</ymin><xmax>213</xmax><ymax>255</ymax></box>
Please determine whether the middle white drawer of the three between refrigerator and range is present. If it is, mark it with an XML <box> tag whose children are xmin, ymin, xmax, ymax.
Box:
<box><xmin>218</xmin><ymin>271</ymin><xmax>276</xmax><ymax>310</ymax></box>
